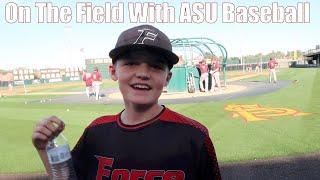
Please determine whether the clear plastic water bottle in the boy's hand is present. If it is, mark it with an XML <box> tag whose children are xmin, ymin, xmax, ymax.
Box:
<box><xmin>46</xmin><ymin>133</ymin><xmax>77</xmax><ymax>180</ymax></box>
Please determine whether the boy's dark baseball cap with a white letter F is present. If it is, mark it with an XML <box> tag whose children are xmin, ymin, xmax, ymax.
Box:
<box><xmin>109</xmin><ymin>25</ymin><xmax>179</xmax><ymax>69</ymax></box>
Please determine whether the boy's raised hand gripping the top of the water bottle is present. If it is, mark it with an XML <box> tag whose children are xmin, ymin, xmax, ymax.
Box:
<box><xmin>32</xmin><ymin>116</ymin><xmax>65</xmax><ymax>150</ymax></box>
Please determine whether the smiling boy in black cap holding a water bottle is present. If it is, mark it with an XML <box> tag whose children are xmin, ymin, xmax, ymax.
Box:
<box><xmin>32</xmin><ymin>25</ymin><xmax>221</xmax><ymax>180</ymax></box>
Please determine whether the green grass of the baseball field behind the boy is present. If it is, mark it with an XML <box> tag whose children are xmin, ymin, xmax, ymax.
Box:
<box><xmin>0</xmin><ymin>69</ymin><xmax>320</xmax><ymax>173</ymax></box>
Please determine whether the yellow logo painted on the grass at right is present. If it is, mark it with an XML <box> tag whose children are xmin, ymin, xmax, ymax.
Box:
<box><xmin>224</xmin><ymin>104</ymin><xmax>311</xmax><ymax>122</ymax></box>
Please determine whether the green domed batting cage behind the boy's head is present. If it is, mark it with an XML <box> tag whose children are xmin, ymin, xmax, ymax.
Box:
<box><xmin>166</xmin><ymin>38</ymin><xmax>227</xmax><ymax>92</ymax></box>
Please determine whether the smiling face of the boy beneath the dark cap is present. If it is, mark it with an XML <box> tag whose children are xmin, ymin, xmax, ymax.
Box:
<box><xmin>109</xmin><ymin>50</ymin><xmax>172</xmax><ymax>105</ymax></box>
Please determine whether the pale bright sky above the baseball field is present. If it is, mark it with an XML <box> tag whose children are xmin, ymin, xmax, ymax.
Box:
<box><xmin>0</xmin><ymin>0</ymin><xmax>320</xmax><ymax>70</ymax></box>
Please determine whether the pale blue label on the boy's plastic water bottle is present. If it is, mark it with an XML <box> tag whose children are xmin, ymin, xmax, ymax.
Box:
<box><xmin>47</xmin><ymin>145</ymin><xmax>71</xmax><ymax>164</ymax></box>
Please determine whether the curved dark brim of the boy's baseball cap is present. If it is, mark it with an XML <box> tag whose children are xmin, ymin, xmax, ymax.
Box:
<box><xmin>109</xmin><ymin>44</ymin><xmax>179</xmax><ymax>69</ymax></box>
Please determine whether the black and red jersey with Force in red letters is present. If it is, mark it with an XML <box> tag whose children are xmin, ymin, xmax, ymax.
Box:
<box><xmin>72</xmin><ymin>108</ymin><xmax>221</xmax><ymax>180</ymax></box>
